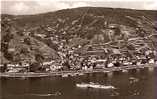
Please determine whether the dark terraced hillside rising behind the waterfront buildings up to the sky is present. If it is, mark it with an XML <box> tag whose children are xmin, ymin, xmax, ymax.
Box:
<box><xmin>1</xmin><ymin>7</ymin><xmax>157</xmax><ymax>63</ymax></box>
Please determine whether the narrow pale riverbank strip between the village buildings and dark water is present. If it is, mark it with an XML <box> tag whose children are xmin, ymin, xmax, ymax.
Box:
<box><xmin>0</xmin><ymin>64</ymin><xmax>156</xmax><ymax>78</ymax></box>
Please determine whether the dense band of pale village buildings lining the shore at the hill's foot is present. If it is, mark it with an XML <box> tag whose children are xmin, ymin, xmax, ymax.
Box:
<box><xmin>0</xmin><ymin>41</ymin><xmax>157</xmax><ymax>72</ymax></box>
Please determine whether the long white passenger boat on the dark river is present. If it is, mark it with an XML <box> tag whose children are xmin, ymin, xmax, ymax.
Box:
<box><xmin>76</xmin><ymin>82</ymin><xmax>115</xmax><ymax>89</ymax></box>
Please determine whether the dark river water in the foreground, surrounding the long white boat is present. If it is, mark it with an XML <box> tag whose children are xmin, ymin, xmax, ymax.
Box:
<box><xmin>0</xmin><ymin>69</ymin><xmax>157</xmax><ymax>99</ymax></box>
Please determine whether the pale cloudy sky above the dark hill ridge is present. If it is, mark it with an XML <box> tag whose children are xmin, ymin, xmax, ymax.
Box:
<box><xmin>0</xmin><ymin>0</ymin><xmax>157</xmax><ymax>15</ymax></box>
